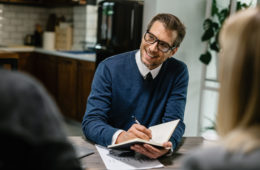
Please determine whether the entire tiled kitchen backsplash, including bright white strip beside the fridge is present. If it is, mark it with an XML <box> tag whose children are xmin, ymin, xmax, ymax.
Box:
<box><xmin>0</xmin><ymin>4</ymin><xmax>97</xmax><ymax>50</ymax></box>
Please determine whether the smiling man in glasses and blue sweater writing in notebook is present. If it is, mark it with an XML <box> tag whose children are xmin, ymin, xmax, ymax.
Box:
<box><xmin>82</xmin><ymin>14</ymin><xmax>188</xmax><ymax>158</ymax></box>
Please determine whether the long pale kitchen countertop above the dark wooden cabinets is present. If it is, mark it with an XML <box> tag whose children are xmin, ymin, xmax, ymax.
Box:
<box><xmin>0</xmin><ymin>46</ymin><xmax>96</xmax><ymax>62</ymax></box>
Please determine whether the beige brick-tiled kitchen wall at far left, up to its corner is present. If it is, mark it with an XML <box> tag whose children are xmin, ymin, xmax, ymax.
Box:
<box><xmin>0</xmin><ymin>4</ymin><xmax>72</xmax><ymax>45</ymax></box>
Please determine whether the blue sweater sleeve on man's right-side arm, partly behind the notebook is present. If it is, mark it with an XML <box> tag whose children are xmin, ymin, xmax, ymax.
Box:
<box><xmin>162</xmin><ymin>65</ymin><xmax>189</xmax><ymax>150</ymax></box>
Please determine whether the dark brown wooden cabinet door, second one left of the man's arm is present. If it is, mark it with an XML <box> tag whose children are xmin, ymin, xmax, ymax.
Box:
<box><xmin>57</xmin><ymin>57</ymin><xmax>77</xmax><ymax>119</ymax></box>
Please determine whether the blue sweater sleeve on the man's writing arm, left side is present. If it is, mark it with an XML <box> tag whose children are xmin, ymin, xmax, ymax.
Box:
<box><xmin>82</xmin><ymin>62</ymin><xmax>118</xmax><ymax>146</ymax></box>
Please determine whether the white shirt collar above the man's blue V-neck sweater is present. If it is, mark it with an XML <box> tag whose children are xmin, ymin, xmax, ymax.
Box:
<box><xmin>135</xmin><ymin>50</ymin><xmax>162</xmax><ymax>79</ymax></box>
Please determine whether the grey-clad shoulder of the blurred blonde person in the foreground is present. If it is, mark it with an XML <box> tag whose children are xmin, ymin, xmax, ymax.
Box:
<box><xmin>181</xmin><ymin>146</ymin><xmax>260</xmax><ymax>170</ymax></box>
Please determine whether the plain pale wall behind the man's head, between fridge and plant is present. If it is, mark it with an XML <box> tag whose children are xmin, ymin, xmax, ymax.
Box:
<box><xmin>142</xmin><ymin>0</ymin><xmax>206</xmax><ymax>136</ymax></box>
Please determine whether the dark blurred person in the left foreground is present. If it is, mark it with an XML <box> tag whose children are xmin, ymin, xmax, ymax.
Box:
<box><xmin>0</xmin><ymin>69</ymin><xmax>81</xmax><ymax>170</ymax></box>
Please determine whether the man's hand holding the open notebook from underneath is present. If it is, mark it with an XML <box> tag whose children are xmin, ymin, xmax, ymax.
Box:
<box><xmin>131</xmin><ymin>142</ymin><xmax>172</xmax><ymax>159</ymax></box>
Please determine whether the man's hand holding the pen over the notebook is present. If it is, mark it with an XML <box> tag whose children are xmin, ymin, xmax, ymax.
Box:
<box><xmin>116</xmin><ymin>124</ymin><xmax>152</xmax><ymax>144</ymax></box>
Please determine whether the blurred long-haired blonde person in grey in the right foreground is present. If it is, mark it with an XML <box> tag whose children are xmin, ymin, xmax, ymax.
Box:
<box><xmin>182</xmin><ymin>6</ymin><xmax>260</xmax><ymax>170</ymax></box>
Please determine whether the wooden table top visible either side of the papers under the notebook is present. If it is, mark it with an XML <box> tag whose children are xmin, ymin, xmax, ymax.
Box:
<box><xmin>69</xmin><ymin>136</ymin><xmax>203</xmax><ymax>170</ymax></box>
